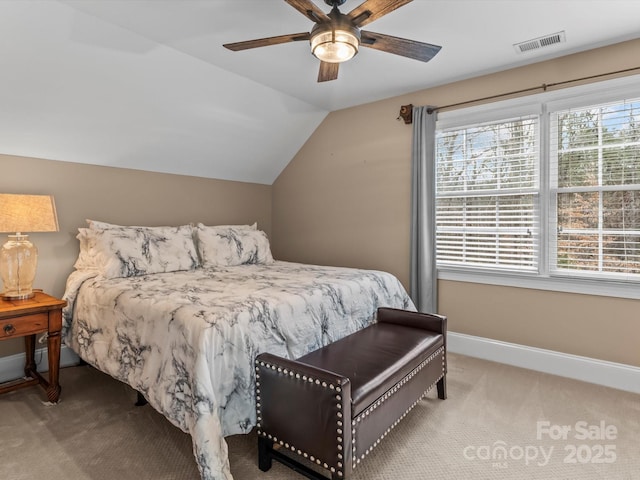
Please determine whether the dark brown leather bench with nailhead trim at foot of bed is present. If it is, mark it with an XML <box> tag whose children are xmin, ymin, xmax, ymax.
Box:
<box><xmin>256</xmin><ymin>308</ymin><xmax>447</xmax><ymax>480</ymax></box>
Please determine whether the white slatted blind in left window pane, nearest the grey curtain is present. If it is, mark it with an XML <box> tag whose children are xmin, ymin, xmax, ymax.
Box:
<box><xmin>436</xmin><ymin>116</ymin><xmax>540</xmax><ymax>271</ymax></box>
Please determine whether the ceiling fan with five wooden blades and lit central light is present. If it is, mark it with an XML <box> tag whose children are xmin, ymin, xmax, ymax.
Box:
<box><xmin>223</xmin><ymin>0</ymin><xmax>442</xmax><ymax>82</ymax></box>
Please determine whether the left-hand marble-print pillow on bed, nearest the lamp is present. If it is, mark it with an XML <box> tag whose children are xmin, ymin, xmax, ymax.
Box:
<box><xmin>75</xmin><ymin>225</ymin><xmax>199</xmax><ymax>278</ymax></box>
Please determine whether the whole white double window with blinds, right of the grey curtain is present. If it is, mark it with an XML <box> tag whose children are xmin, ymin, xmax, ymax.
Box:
<box><xmin>436</xmin><ymin>78</ymin><xmax>640</xmax><ymax>298</ymax></box>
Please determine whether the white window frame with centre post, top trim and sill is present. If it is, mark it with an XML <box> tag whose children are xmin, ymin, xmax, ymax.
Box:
<box><xmin>436</xmin><ymin>75</ymin><xmax>640</xmax><ymax>299</ymax></box>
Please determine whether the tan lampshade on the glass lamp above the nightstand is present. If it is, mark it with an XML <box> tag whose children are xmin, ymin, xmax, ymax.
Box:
<box><xmin>0</xmin><ymin>193</ymin><xmax>58</xmax><ymax>233</ymax></box>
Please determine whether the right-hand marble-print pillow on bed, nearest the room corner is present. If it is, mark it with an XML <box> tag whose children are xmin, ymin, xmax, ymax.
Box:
<box><xmin>195</xmin><ymin>224</ymin><xmax>273</xmax><ymax>267</ymax></box>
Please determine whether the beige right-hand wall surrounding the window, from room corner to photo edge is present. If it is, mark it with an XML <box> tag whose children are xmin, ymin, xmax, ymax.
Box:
<box><xmin>272</xmin><ymin>40</ymin><xmax>640</xmax><ymax>366</ymax></box>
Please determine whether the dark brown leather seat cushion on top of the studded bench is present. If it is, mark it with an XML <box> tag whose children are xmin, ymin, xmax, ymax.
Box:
<box><xmin>298</xmin><ymin>323</ymin><xmax>444</xmax><ymax>417</ymax></box>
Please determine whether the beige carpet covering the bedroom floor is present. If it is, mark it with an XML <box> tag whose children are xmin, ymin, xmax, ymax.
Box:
<box><xmin>0</xmin><ymin>354</ymin><xmax>640</xmax><ymax>480</ymax></box>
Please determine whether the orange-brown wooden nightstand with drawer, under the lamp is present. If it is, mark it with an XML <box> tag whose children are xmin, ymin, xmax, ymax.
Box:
<box><xmin>0</xmin><ymin>292</ymin><xmax>67</xmax><ymax>403</ymax></box>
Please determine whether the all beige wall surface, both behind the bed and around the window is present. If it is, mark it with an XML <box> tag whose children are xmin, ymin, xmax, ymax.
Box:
<box><xmin>0</xmin><ymin>40</ymin><xmax>640</xmax><ymax>366</ymax></box>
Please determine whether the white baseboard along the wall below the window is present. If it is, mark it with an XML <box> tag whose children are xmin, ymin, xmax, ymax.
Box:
<box><xmin>447</xmin><ymin>332</ymin><xmax>640</xmax><ymax>393</ymax></box>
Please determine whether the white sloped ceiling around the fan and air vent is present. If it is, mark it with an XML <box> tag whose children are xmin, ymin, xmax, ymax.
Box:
<box><xmin>0</xmin><ymin>0</ymin><xmax>640</xmax><ymax>184</ymax></box>
